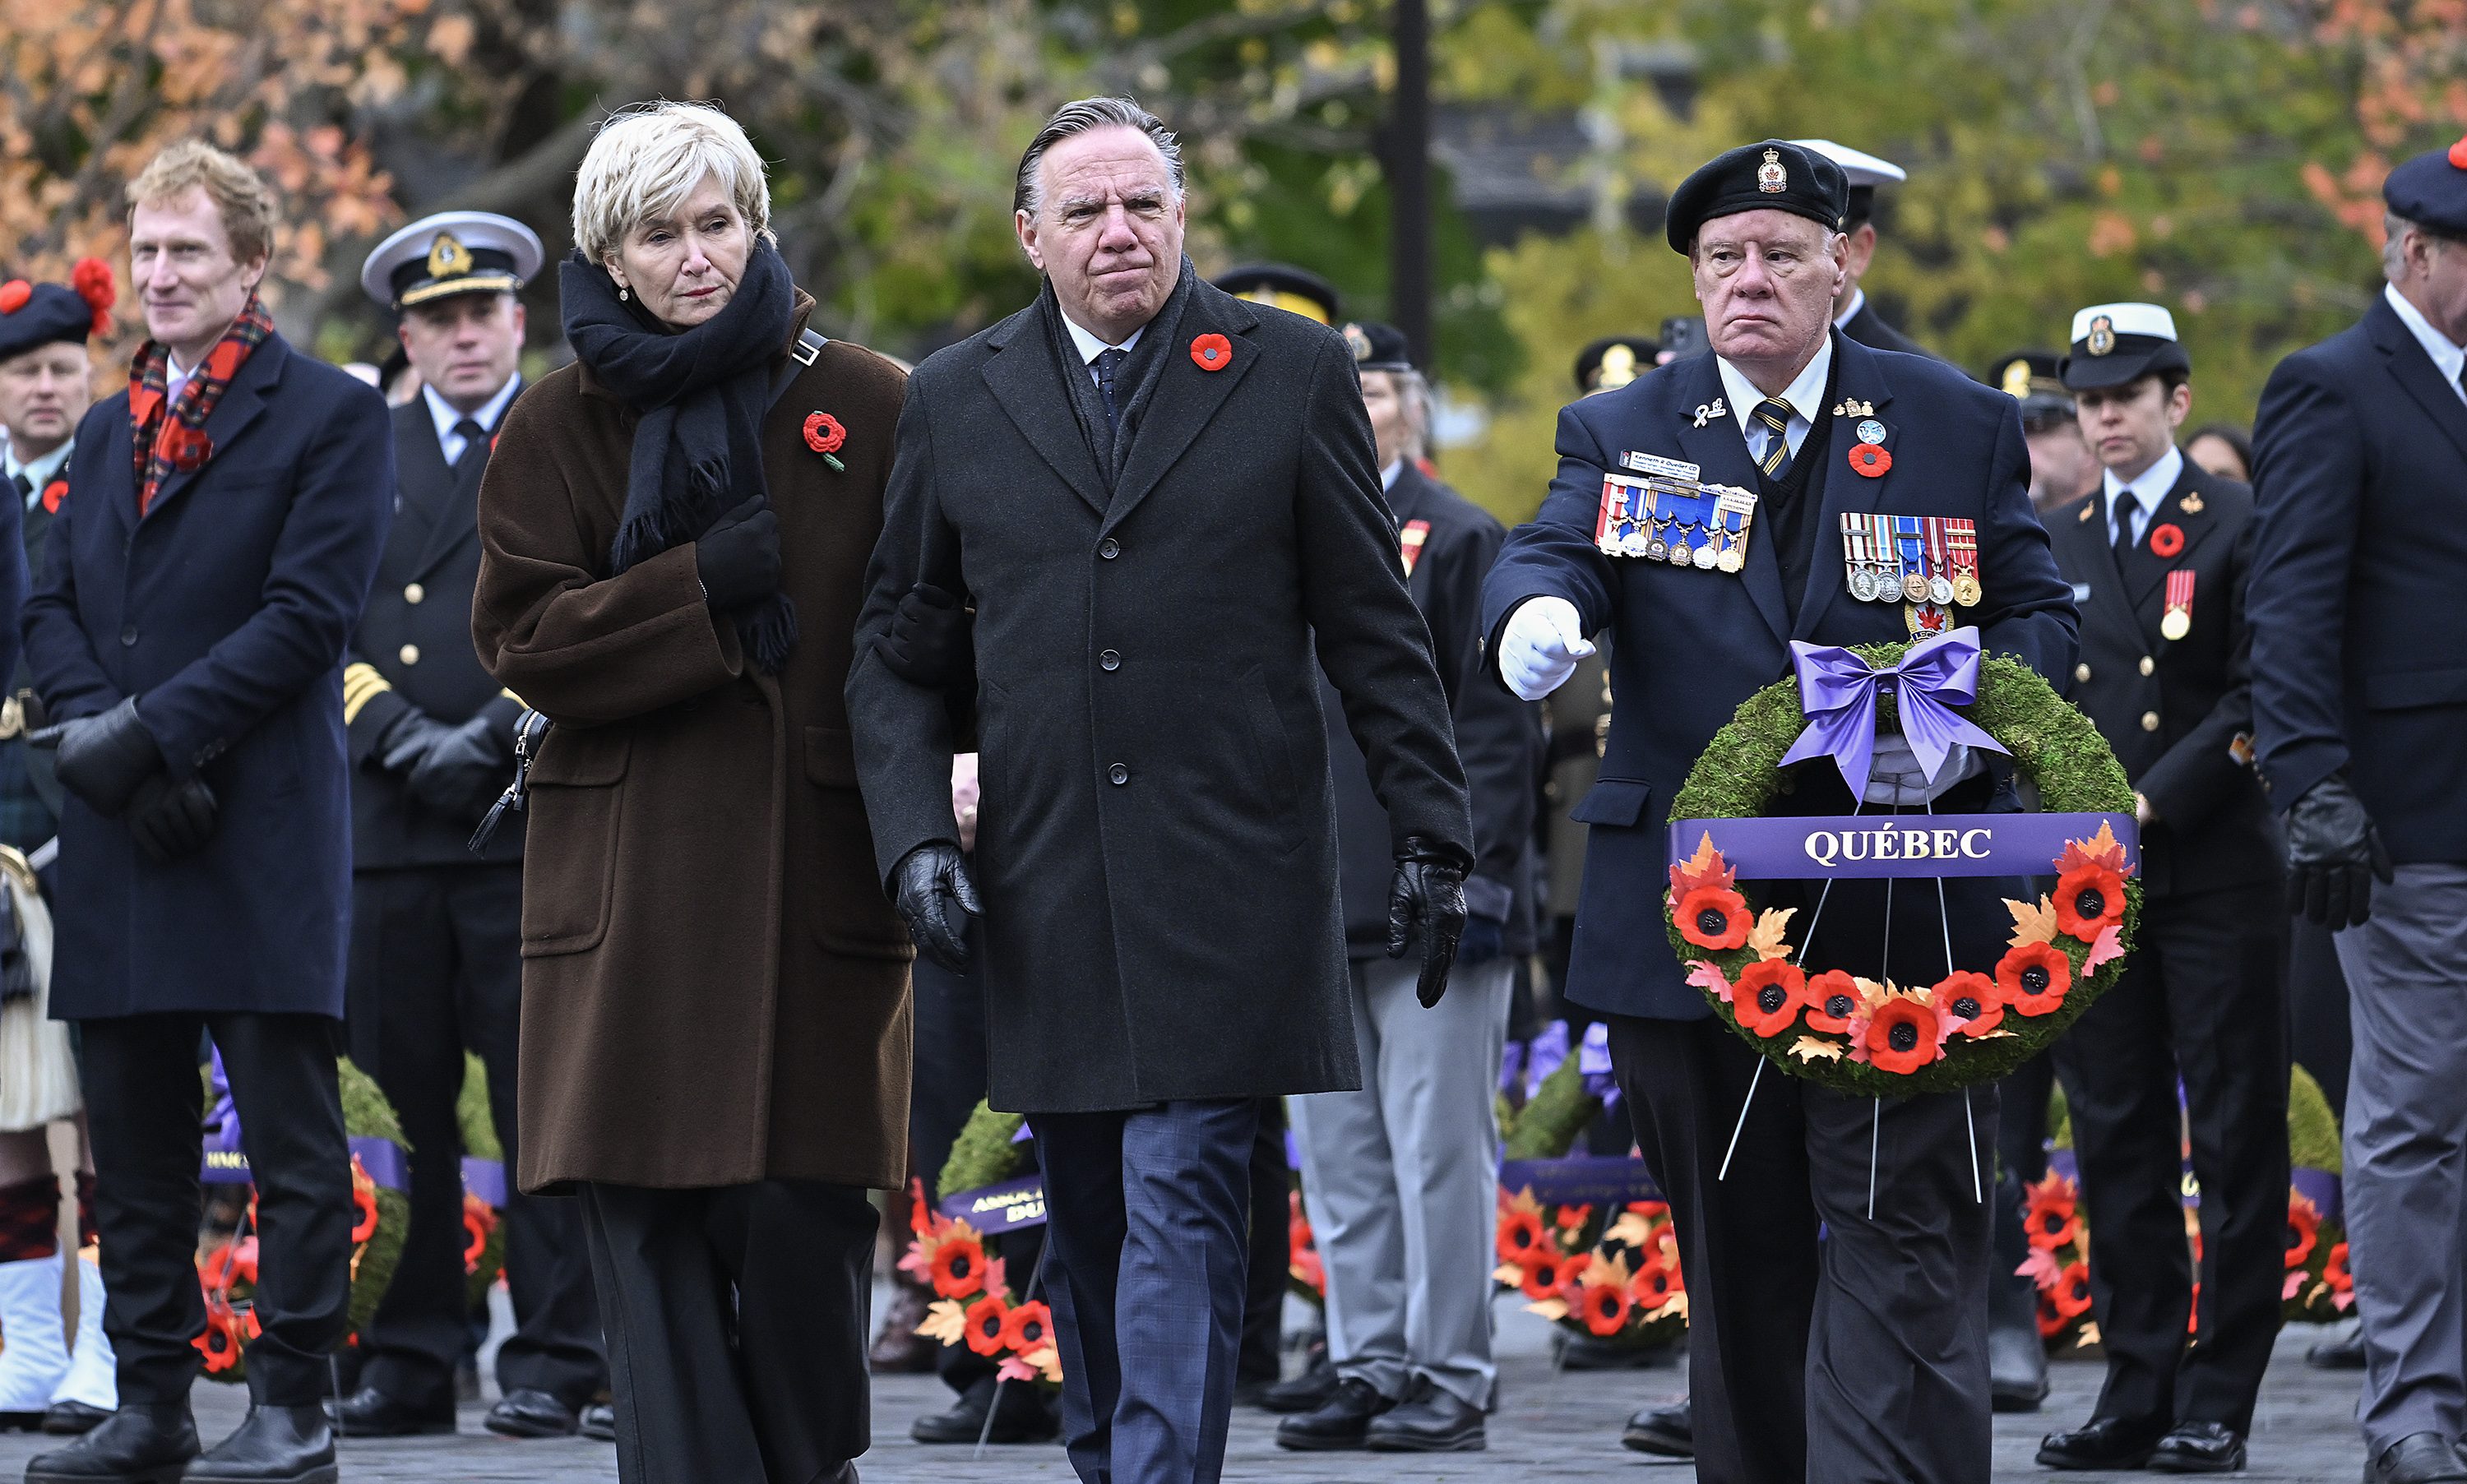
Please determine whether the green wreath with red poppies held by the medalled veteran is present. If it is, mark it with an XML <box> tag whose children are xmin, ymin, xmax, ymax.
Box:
<box><xmin>1663</xmin><ymin>644</ymin><xmax>2141</xmax><ymax>1097</ymax></box>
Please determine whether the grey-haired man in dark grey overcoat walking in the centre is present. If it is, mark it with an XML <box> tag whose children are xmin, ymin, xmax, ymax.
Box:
<box><xmin>849</xmin><ymin>99</ymin><xmax>1473</xmax><ymax>1484</ymax></box>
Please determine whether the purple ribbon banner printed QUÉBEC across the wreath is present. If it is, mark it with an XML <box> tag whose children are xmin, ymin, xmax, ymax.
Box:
<box><xmin>1670</xmin><ymin>813</ymin><xmax>2141</xmax><ymax>880</ymax></box>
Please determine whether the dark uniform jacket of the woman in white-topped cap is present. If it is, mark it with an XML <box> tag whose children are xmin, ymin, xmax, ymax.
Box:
<box><xmin>2048</xmin><ymin>459</ymin><xmax>2280</xmax><ymax>892</ymax></box>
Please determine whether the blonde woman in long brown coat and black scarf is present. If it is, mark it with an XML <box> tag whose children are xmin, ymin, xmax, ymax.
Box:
<box><xmin>471</xmin><ymin>104</ymin><xmax>910</xmax><ymax>1484</ymax></box>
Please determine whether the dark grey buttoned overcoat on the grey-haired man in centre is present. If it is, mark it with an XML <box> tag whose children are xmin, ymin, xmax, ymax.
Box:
<box><xmin>849</xmin><ymin>266</ymin><xmax>1470</xmax><ymax>1112</ymax></box>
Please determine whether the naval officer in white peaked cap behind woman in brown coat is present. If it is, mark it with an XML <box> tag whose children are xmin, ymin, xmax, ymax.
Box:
<box><xmin>338</xmin><ymin>212</ymin><xmax>607</xmax><ymax>1437</ymax></box>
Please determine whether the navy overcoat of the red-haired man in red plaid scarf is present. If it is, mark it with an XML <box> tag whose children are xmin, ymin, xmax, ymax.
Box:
<box><xmin>25</xmin><ymin>335</ymin><xmax>395</xmax><ymax>1020</ymax></box>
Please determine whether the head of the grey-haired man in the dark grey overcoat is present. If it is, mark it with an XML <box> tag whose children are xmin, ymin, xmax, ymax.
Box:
<box><xmin>1014</xmin><ymin>126</ymin><xmax>1184</xmax><ymax>340</ymax></box>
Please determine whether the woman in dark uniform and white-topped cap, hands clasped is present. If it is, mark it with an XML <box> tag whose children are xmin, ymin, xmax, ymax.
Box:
<box><xmin>2038</xmin><ymin>303</ymin><xmax>2287</xmax><ymax>1474</ymax></box>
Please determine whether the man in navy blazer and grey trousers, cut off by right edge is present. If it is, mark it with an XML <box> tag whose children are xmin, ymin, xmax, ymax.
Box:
<box><xmin>2247</xmin><ymin>141</ymin><xmax>2467</xmax><ymax>1484</ymax></box>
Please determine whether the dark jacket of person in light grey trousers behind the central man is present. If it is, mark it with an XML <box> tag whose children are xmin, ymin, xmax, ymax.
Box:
<box><xmin>1320</xmin><ymin>461</ymin><xmax>1542</xmax><ymax>959</ymax></box>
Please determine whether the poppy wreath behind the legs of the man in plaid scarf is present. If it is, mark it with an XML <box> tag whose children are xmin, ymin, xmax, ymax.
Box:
<box><xmin>195</xmin><ymin>1060</ymin><xmax>412</xmax><ymax>1380</ymax></box>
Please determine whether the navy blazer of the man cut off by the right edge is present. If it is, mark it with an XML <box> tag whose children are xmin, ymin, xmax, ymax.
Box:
<box><xmin>2247</xmin><ymin>288</ymin><xmax>2467</xmax><ymax>862</ymax></box>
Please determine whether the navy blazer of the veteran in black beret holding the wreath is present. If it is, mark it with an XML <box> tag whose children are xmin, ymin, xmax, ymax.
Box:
<box><xmin>1483</xmin><ymin>331</ymin><xmax>2077</xmax><ymax>1020</ymax></box>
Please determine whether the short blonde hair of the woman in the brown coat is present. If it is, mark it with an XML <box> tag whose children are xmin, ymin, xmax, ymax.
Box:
<box><xmin>575</xmin><ymin>101</ymin><xmax>772</xmax><ymax>264</ymax></box>
